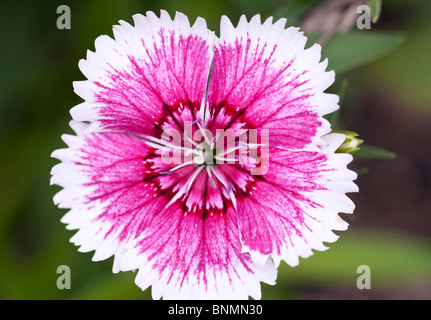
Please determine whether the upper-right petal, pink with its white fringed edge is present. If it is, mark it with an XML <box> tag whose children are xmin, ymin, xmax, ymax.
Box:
<box><xmin>208</xmin><ymin>15</ymin><xmax>338</xmax><ymax>150</ymax></box>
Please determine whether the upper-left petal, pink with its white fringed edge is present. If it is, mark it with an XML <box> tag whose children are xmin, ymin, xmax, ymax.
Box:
<box><xmin>71</xmin><ymin>11</ymin><xmax>213</xmax><ymax>135</ymax></box>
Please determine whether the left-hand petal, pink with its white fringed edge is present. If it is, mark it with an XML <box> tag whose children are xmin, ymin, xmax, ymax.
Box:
<box><xmin>51</xmin><ymin>133</ymin><xmax>167</xmax><ymax>260</ymax></box>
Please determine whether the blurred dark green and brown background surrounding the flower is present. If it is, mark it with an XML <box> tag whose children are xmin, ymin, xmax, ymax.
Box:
<box><xmin>0</xmin><ymin>0</ymin><xmax>431</xmax><ymax>299</ymax></box>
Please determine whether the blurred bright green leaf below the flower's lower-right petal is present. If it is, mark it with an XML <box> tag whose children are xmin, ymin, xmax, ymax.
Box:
<box><xmin>263</xmin><ymin>231</ymin><xmax>431</xmax><ymax>299</ymax></box>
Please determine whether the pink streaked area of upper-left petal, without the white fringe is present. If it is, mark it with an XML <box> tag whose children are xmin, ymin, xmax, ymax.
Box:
<box><xmin>95</xmin><ymin>29</ymin><xmax>210</xmax><ymax>135</ymax></box>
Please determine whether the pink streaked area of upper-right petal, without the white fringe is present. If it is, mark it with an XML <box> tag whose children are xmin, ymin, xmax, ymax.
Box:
<box><xmin>208</xmin><ymin>37</ymin><xmax>322</xmax><ymax>149</ymax></box>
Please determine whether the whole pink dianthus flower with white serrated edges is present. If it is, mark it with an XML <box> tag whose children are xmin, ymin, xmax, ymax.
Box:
<box><xmin>51</xmin><ymin>11</ymin><xmax>357</xmax><ymax>299</ymax></box>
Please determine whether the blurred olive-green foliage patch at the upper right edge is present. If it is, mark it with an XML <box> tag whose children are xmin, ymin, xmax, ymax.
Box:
<box><xmin>357</xmin><ymin>0</ymin><xmax>431</xmax><ymax>114</ymax></box>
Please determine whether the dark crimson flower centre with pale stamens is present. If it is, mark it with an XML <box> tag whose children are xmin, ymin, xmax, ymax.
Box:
<box><xmin>146</xmin><ymin>104</ymin><xmax>269</xmax><ymax>207</ymax></box>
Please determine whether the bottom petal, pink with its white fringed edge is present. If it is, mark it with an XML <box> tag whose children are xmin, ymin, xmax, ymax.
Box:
<box><xmin>120</xmin><ymin>205</ymin><xmax>275</xmax><ymax>299</ymax></box>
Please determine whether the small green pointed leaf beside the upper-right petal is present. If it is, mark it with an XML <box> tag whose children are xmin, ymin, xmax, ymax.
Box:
<box><xmin>322</xmin><ymin>31</ymin><xmax>403</xmax><ymax>73</ymax></box>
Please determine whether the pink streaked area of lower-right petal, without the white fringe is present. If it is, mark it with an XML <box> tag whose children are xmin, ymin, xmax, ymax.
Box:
<box><xmin>237</xmin><ymin>149</ymin><xmax>327</xmax><ymax>254</ymax></box>
